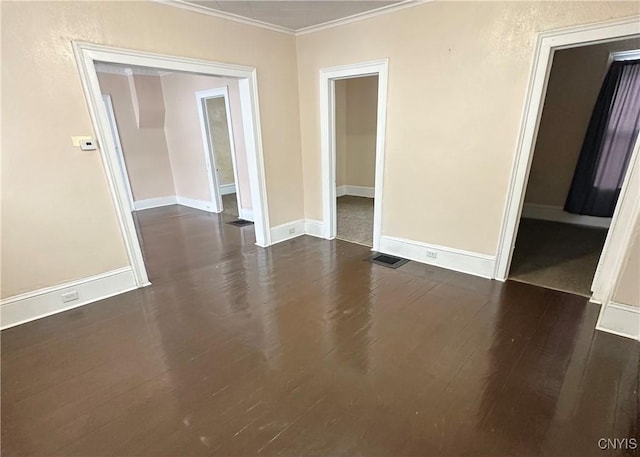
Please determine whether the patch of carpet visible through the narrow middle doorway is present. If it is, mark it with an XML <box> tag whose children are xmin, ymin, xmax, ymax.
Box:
<box><xmin>337</xmin><ymin>195</ymin><xmax>373</xmax><ymax>246</ymax></box>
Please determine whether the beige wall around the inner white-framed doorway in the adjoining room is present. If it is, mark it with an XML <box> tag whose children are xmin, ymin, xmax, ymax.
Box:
<box><xmin>161</xmin><ymin>73</ymin><xmax>254</xmax><ymax>208</ymax></box>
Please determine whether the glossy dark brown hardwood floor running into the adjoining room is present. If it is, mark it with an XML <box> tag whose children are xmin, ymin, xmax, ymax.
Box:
<box><xmin>1</xmin><ymin>206</ymin><xmax>640</xmax><ymax>457</ymax></box>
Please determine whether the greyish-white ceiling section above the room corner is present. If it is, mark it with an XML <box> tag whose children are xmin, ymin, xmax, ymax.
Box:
<box><xmin>172</xmin><ymin>0</ymin><xmax>412</xmax><ymax>32</ymax></box>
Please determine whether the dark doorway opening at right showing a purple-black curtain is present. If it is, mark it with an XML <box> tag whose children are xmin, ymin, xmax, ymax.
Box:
<box><xmin>509</xmin><ymin>39</ymin><xmax>640</xmax><ymax>297</ymax></box>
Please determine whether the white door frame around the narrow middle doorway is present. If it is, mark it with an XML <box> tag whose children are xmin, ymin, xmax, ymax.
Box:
<box><xmin>320</xmin><ymin>59</ymin><xmax>389</xmax><ymax>251</ymax></box>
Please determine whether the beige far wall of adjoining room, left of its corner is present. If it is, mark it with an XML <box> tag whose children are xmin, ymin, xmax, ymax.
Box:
<box><xmin>98</xmin><ymin>73</ymin><xmax>176</xmax><ymax>201</ymax></box>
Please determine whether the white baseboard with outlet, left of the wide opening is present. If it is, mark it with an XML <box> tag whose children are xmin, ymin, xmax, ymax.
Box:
<box><xmin>0</xmin><ymin>267</ymin><xmax>137</xmax><ymax>329</ymax></box>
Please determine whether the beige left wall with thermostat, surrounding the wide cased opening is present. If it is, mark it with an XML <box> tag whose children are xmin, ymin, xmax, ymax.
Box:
<box><xmin>0</xmin><ymin>2</ymin><xmax>303</xmax><ymax>297</ymax></box>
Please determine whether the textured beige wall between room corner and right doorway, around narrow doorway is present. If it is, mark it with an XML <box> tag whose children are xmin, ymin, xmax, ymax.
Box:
<box><xmin>297</xmin><ymin>2</ymin><xmax>640</xmax><ymax>255</ymax></box>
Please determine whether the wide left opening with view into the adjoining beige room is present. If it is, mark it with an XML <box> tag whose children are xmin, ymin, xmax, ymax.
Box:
<box><xmin>96</xmin><ymin>63</ymin><xmax>255</xmax><ymax>280</ymax></box>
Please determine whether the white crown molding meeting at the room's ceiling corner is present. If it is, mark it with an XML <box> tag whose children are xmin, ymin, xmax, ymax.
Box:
<box><xmin>151</xmin><ymin>0</ymin><xmax>428</xmax><ymax>36</ymax></box>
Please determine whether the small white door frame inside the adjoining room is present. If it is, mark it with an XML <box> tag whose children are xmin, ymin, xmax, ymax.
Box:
<box><xmin>196</xmin><ymin>86</ymin><xmax>242</xmax><ymax>220</ymax></box>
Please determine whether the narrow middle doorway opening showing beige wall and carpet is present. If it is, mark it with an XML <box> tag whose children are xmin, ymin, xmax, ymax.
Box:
<box><xmin>335</xmin><ymin>75</ymin><xmax>378</xmax><ymax>247</ymax></box>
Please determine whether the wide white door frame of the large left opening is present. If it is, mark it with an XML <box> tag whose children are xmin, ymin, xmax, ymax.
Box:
<box><xmin>71</xmin><ymin>41</ymin><xmax>271</xmax><ymax>287</ymax></box>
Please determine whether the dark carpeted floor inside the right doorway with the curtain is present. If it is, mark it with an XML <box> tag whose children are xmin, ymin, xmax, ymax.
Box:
<box><xmin>509</xmin><ymin>218</ymin><xmax>607</xmax><ymax>297</ymax></box>
